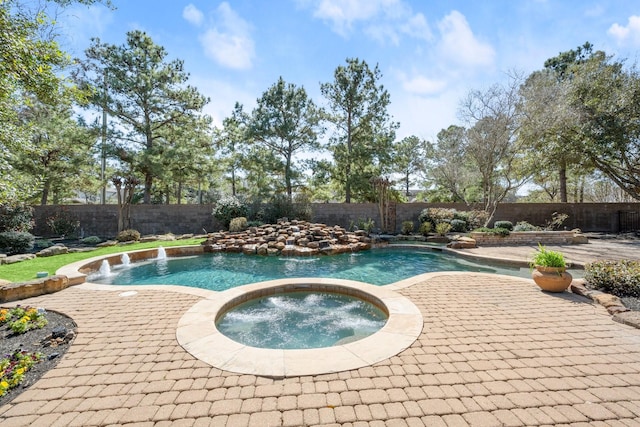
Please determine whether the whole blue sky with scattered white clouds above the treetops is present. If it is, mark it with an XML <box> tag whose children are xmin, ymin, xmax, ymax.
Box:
<box><xmin>58</xmin><ymin>0</ymin><xmax>640</xmax><ymax>141</ymax></box>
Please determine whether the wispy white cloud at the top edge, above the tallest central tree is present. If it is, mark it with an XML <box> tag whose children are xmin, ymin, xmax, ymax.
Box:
<box><xmin>298</xmin><ymin>0</ymin><xmax>431</xmax><ymax>45</ymax></box>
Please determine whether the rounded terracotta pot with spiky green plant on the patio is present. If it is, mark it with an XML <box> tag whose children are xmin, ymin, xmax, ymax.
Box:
<box><xmin>531</xmin><ymin>244</ymin><xmax>573</xmax><ymax>292</ymax></box>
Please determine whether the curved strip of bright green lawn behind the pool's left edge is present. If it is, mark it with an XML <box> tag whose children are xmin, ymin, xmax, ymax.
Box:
<box><xmin>0</xmin><ymin>239</ymin><xmax>204</xmax><ymax>282</ymax></box>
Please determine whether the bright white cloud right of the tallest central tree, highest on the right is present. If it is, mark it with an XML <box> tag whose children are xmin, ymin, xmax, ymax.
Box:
<box><xmin>438</xmin><ymin>10</ymin><xmax>495</xmax><ymax>66</ymax></box>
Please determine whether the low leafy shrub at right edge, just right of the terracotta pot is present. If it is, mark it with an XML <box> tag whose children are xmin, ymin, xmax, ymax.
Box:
<box><xmin>584</xmin><ymin>260</ymin><xmax>640</xmax><ymax>297</ymax></box>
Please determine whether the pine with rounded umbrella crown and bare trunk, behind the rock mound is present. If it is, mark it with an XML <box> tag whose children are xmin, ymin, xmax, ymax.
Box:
<box><xmin>248</xmin><ymin>77</ymin><xmax>322</xmax><ymax>202</ymax></box>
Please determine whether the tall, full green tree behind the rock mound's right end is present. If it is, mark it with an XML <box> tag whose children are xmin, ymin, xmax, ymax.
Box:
<box><xmin>320</xmin><ymin>58</ymin><xmax>398</xmax><ymax>203</ymax></box>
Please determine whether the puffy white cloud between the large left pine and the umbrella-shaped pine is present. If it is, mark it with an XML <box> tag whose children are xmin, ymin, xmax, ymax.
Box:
<box><xmin>199</xmin><ymin>2</ymin><xmax>255</xmax><ymax>70</ymax></box>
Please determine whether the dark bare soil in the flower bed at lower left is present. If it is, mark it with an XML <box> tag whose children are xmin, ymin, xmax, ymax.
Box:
<box><xmin>0</xmin><ymin>310</ymin><xmax>77</xmax><ymax>406</ymax></box>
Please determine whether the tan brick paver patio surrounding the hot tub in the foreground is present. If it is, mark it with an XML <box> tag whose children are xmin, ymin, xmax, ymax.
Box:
<box><xmin>0</xmin><ymin>273</ymin><xmax>640</xmax><ymax>427</ymax></box>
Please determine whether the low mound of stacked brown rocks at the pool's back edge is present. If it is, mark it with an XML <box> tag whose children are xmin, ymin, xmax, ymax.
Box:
<box><xmin>202</xmin><ymin>220</ymin><xmax>371</xmax><ymax>256</ymax></box>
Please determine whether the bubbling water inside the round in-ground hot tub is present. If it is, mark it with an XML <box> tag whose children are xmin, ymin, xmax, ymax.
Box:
<box><xmin>216</xmin><ymin>292</ymin><xmax>387</xmax><ymax>349</ymax></box>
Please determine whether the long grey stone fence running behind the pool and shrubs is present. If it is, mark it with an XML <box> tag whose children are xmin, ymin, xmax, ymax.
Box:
<box><xmin>33</xmin><ymin>203</ymin><xmax>640</xmax><ymax>237</ymax></box>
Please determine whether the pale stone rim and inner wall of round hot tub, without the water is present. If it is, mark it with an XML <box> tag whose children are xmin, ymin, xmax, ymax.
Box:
<box><xmin>176</xmin><ymin>278</ymin><xmax>423</xmax><ymax>377</ymax></box>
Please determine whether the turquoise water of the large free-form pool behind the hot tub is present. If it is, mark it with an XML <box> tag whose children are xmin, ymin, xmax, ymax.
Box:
<box><xmin>88</xmin><ymin>248</ymin><xmax>531</xmax><ymax>291</ymax></box>
